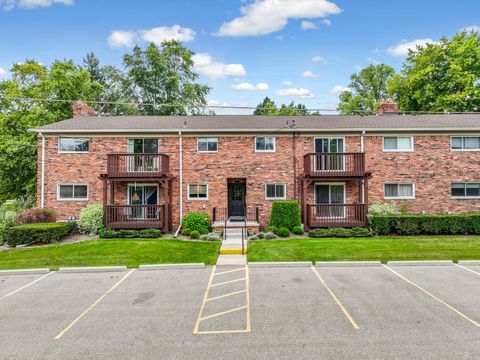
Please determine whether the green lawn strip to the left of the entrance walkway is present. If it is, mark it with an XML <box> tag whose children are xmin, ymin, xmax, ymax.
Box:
<box><xmin>0</xmin><ymin>239</ymin><xmax>220</xmax><ymax>270</ymax></box>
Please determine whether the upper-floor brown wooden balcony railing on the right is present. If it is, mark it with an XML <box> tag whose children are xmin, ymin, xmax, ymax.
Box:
<box><xmin>303</xmin><ymin>153</ymin><xmax>365</xmax><ymax>177</ymax></box>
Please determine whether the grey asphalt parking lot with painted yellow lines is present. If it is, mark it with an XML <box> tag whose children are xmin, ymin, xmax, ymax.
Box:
<box><xmin>0</xmin><ymin>265</ymin><xmax>480</xmax><ymax>359</ymax></box>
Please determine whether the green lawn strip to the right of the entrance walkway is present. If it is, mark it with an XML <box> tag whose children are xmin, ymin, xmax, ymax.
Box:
<box><xmin>248</xmin><ymin>236</ymin><xmax>480</xmax><ymax>262</ymax></box>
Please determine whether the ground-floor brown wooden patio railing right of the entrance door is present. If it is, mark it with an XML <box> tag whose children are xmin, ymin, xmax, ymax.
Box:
<box><xmin>307</xmin><ymin>204</ymin><xmax>368</xmax><ymax>228</ymax></box>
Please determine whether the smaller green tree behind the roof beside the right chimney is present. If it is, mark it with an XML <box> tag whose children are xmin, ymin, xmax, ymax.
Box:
<box><xmin>338</xmin><ymin>64</ymin><xmax>395</xmax><ymax>115</ymax></box>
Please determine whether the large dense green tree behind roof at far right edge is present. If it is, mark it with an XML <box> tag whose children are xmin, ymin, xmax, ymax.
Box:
<box><xmin>389</xmin><ymin>32</ymin><xmax>480</xmax><ymax>112</ymax></box>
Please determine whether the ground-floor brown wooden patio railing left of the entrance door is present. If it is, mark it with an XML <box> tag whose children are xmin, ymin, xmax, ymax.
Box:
<box><xmin>105</xmin><ymin>204</ymin><xmax>166</xmax><ymax>229</ymax></box>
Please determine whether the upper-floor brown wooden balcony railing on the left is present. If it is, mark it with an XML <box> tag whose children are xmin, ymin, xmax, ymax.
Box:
<box><xmin>107</xmin><ymin>154</ymin><xmax>170</xmax><ymax>177</ymax></box>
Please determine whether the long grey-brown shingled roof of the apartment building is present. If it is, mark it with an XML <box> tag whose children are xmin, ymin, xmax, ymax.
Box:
<box><xmin>27</xmin><ymin>114</ymin><xmax>480</xmax><ymax>133</ymax></box>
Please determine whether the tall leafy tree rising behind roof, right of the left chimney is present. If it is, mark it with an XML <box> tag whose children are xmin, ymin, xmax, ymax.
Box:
<box><xmin>123</xmin><ymin>41</ymin><xmax>210</xmax><ymax>115</ymax></box>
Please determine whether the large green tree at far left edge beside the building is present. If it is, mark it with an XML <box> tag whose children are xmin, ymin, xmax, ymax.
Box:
<box><xmin>0</xmin><ymin>60</ymin><xmax>103</xmax><ymax>202</ymax></box>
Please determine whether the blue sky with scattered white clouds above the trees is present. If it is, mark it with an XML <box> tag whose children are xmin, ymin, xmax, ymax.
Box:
<box><xmin>0</xmin><ymin>0</ymin><xmax>480</xmax><ymax>113</ymax></box>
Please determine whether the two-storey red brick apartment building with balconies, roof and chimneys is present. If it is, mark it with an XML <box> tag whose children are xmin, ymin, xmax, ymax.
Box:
<box><xmin>32</xmin><ymin>102</ymin><xmax>480</xmax><ymax>231</ymax></box>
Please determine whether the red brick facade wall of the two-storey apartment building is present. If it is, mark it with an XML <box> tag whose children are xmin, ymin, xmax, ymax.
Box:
<box><xmin>38</xmin><ymin>135</ymin><xmax>480</xmax><ymax>226</ymax></box>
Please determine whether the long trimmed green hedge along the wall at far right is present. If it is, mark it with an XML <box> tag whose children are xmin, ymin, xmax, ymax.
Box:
<box><xmin>370</xmin><ymin>213</ymin><xmax>480</xmax><ymax>235</ymax></box>
